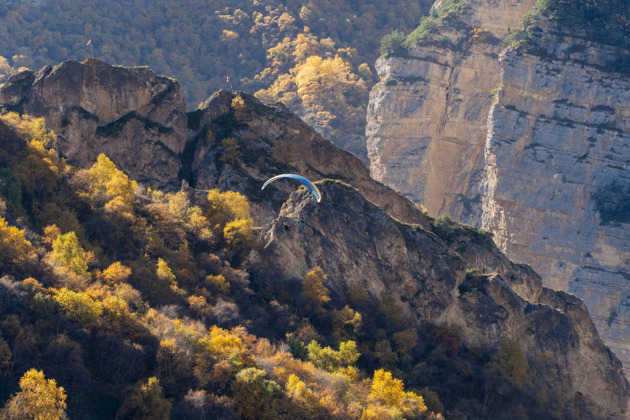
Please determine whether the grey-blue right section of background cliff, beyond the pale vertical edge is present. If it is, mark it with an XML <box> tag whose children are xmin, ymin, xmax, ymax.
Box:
<box><xmin>481</xmin><ymin>22</ymin><xmax>630</xmax><ymax>364</ymax></box>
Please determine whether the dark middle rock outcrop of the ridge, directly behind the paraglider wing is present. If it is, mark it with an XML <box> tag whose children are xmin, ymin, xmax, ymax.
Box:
<box><xmin>185</xmin><ymin>91</ymin><xmax>429</xmax><ymax>229</ymax></box>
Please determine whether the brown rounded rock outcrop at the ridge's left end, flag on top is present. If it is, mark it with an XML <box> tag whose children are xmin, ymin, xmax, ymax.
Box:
<box><xmin>0</xmin><ymin>59</ymin><xmax>187</xmax><ymax>188</ymax></box>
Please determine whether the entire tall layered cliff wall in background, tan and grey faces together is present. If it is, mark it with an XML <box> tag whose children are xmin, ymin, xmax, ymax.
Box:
<box><xmin>368</xmin><ymin>2</ymin><xmax>630</xmax><ymax>367</ymax></box>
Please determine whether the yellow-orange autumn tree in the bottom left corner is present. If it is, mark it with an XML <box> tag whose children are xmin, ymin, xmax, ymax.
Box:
<box><xmin>0</xmin><ymin>369</ymin><xmax>66</xmax><ymax>420</ymax></box>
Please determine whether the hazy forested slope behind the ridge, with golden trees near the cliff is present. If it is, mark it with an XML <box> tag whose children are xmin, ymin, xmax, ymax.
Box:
<box><xmin>0</xmin><ymin>0</ymin><xmax>432</xmax><ymax>156</ymax></box>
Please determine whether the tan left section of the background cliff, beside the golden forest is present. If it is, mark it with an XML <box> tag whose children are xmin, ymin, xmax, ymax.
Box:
<box><xmin>366</xmin><ymin>0</ymin><xmax>534</xmax><ymax>217</ymax></box>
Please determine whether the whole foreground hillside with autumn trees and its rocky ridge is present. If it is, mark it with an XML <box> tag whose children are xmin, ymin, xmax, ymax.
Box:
<box><xmin>0</xmin><ymin>60</ymin><xmax>630</xmax><ymax>420</ymax></box>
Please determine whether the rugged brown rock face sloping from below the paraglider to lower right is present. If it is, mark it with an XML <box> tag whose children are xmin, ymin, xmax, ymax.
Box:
<box><xmin>257</xmin><ymin>181</ymin><xmax>628</xmax><ymax>418</ymax></box>
